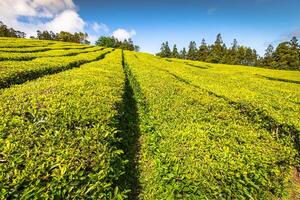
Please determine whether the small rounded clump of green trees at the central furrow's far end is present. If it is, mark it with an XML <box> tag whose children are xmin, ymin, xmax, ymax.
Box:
<box><xmin>96</xmin><ymin>36</ymin><xmax>140</xmax><ymax>51</ymax></box>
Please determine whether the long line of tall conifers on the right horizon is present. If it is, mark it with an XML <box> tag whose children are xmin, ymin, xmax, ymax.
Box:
<box><xmin>156</xmin><ymin>34</ymin><xmax>300</xmax><ymax>70</ymax></box>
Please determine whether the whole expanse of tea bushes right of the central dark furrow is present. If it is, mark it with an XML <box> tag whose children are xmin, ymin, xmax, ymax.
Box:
<box><xmin>125</xmin><ymin>52</ymin><xmax>300</xmax><ymax>199</ymax></box>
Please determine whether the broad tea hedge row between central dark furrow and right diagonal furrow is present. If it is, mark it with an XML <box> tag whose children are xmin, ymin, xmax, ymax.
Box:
<box><xmin>125</xmin><ymin>52</ymin><xmax>296</xmax><ymax>199</ymax></box>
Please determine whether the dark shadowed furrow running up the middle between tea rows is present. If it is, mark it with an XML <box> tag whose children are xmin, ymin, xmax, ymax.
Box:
<box><xmin>118</xmin><ymin>51</ymin><xmax>140</xmax><ymax>200</ymax></box>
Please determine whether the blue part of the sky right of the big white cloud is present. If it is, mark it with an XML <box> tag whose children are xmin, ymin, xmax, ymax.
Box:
<box><xmin>74</xmin><ymin>0</ymin><xmax>300</xmax><ymax>53</ymax></box>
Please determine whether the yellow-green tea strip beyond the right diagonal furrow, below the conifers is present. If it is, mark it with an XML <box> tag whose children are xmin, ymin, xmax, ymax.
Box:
<box><xmin>167</xmin><ymin>57</ymin><xmax>300</xmax><ymax>130</ymax></box>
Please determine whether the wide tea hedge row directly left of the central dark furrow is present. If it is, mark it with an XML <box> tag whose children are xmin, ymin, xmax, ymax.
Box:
<box><xmin>0</xmin><ymin>50</ymin><xmax>127</xmax><ymax>199</ymax></box>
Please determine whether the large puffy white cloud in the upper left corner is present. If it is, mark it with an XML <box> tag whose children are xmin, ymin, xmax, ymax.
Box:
<box><xmin>0</xmin><ymin>0</ymin><xmax>85</xmax><ymax>36</ymax></box>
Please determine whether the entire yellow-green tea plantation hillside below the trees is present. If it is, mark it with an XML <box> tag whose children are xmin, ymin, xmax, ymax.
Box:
<box><xmin>0</xmin><ymin>38</ymin><xmax>300</xmax><ymax>199</ymax></box>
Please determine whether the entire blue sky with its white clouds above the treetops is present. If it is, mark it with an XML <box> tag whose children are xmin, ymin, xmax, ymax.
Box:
<box><xmin>0</xmin><ymin>0</ymin><xmax>300</xmax><ymax>55</ymax></box>
